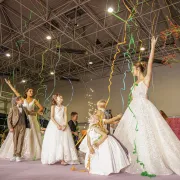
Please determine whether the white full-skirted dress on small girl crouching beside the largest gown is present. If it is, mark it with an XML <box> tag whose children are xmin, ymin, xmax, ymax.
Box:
<box><xmin>85</xmin><ymin>126</ymin><xmax>129</xmax><ymax>175</ymax></box>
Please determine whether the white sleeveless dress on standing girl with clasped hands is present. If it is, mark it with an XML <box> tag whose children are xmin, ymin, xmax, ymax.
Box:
<box><xmin>41</xmin><ymin>106</ymin><xmax>79</xmax><ymax>164</ymax></box>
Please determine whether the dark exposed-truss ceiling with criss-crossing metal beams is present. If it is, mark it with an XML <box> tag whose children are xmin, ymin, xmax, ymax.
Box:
<box><xmin>0</xmin><ymin>0</ymin><xmax>180</xmax><ymax>84</ymax></box>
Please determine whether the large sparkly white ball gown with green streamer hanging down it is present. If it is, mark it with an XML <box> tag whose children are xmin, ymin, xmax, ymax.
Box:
<box><xmin>114</xmin><ymin>81</ymin><xmax>180</xmax><ymax>175</ymax></box>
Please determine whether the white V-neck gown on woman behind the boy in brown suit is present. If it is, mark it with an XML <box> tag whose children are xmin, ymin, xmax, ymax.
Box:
<box><xmin>0</xmin><ymin>99</ymin><xmax>42</xmax><ymax>160</ymax></box>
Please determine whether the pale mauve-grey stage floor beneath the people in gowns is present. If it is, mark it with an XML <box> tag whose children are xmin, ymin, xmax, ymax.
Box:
<box><xmin>0</xmin><ymin>160</ymin><xmax>180</xmax><ymax>180</ymax></box>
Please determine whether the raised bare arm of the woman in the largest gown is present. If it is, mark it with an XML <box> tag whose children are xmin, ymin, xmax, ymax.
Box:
<box><xmin>144</xmin><ymin>36</ymin><xmax>158</xmax><ymax>87</ymax></box>
